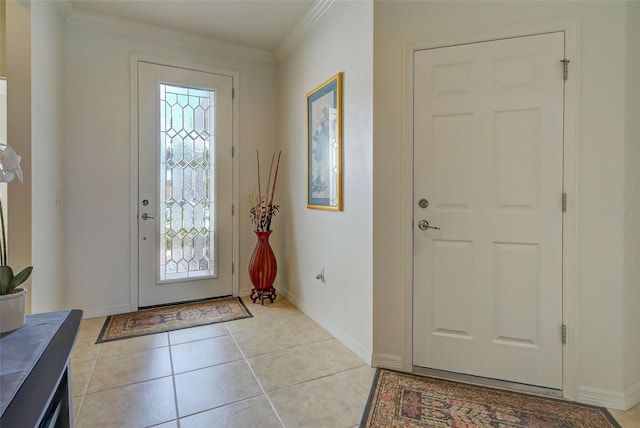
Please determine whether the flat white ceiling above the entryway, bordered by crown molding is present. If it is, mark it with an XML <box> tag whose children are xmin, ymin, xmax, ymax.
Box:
<box><xmin>71</xmin><ymin>0</ymin><xmax>315</xmax><ymax>52</ymax></box>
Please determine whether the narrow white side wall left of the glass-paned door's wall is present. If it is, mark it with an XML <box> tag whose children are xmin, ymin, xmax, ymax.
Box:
<box><xmin>31</xmin><ymin>1</ymin><xmax>66</xmax><ymax>313</ymax></box>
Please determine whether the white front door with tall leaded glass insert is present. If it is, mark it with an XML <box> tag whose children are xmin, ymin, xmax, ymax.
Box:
<box><xmin>138</xmin><ymin>62</ymin><xmax>233</xmax><ymax>307</ymax></box>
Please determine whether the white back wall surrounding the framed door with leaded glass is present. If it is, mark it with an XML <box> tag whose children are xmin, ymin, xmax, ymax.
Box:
<box><xmin>63</xmin><ymin>16</ymin><xmax>278</xmax><ymax>316</ymax></box>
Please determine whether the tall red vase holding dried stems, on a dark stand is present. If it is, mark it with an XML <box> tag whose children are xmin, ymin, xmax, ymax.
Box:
<box><xmin>249</xmin><ymin>150</ymin><xmax>281</xmax><ymax>304</ymax></box>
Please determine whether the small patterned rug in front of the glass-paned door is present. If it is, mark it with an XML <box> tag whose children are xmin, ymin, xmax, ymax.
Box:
<box><xmin>96</xmin><ymin>297</ymin><xmax>253</xmax><ymax>343</ymax></box>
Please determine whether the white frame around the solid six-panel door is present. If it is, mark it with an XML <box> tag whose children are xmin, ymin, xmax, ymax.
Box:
<box><xmin>402</xmin><ymin>18</ymin><xmax>579</xmax><ymax>399</ymax></box>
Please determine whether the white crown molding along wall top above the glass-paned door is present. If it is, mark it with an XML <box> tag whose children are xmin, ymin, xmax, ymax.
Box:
<box><xmin>58</xmin><ymin>5</ymin><xmax>276</xmax><ymax>64</ymax></box>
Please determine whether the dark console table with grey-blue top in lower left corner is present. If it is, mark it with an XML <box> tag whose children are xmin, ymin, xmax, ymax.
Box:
<box><xmin>0</xmin><ymin>310</ymin><xmax>82</xmax><ymax>428</ymax></box>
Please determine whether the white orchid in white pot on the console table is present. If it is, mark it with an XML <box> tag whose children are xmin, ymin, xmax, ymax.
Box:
<box><xmin>0</xmin><ymin>147</ymin><xmax>33</xmax><ymax>333</ymax></box>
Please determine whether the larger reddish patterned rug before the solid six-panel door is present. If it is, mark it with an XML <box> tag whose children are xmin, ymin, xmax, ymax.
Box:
<box><xmin>360</xmin><ymin>369</ymin><xmax>620</xmax><ymax>428</ymax></box>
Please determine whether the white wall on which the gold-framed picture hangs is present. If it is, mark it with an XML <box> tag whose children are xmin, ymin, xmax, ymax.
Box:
<box><xmin>279</xmin><ymin>1</ymin><xmax>373</xmax><ymax>362</ymax></box>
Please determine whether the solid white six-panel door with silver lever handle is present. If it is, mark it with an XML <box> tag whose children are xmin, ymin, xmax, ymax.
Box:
<box><xmin>413</xmin><ymin>33</ymin><xmax>564</xmax><ymax>389</ymax></box>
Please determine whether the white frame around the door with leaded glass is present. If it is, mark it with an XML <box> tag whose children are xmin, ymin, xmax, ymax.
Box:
<box><xmin>129</xmin><ymin>53</ymin><xmax>240</xmax><ymax>311</ymax></box>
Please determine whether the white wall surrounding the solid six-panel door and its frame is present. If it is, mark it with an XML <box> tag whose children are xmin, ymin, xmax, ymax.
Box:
<box><xmin>373</xmin><ymin>1</ymin><xmax>640</xmax><ymax>407</ymax></box>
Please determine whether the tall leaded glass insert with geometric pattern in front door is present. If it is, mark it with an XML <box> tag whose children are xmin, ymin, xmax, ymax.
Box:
<box><xmin>158</xmin><ymin>83</ymin><xmax>217</xmax><ymax>281</ymax></box>
